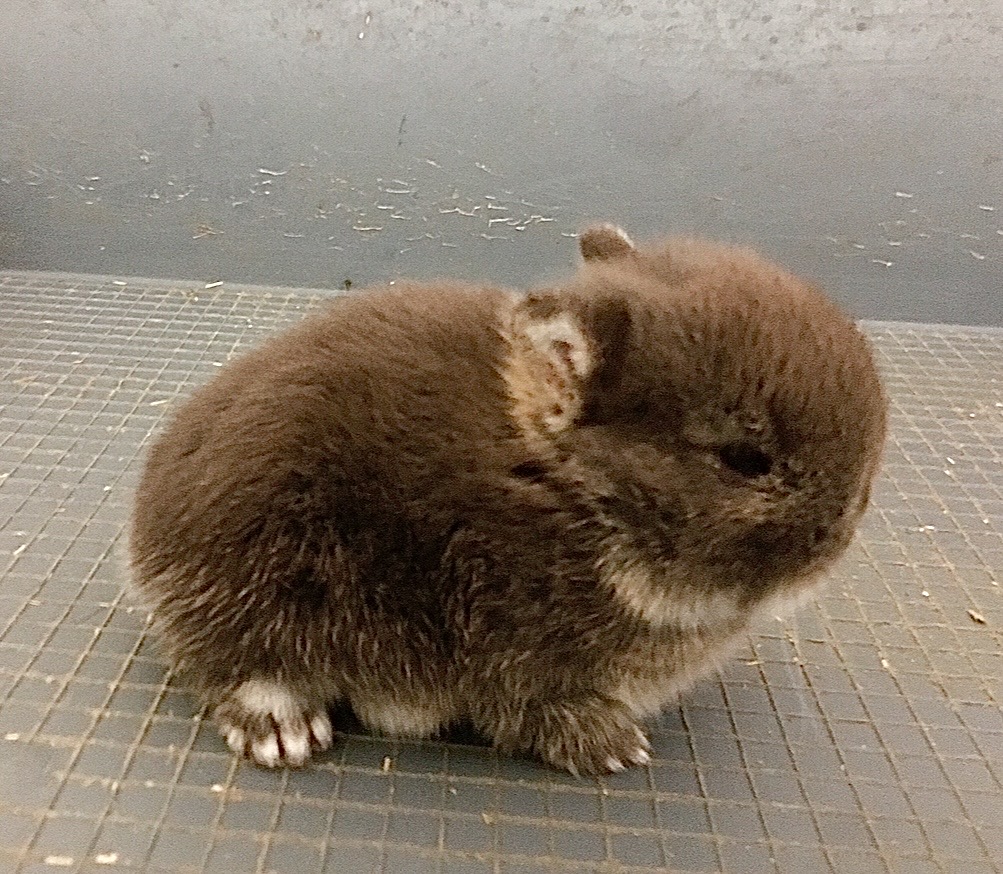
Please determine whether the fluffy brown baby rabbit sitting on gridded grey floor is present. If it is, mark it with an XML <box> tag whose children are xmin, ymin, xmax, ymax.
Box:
<box><xmin>131</xmin><ymin>226</ymin><xmax>886</xmax><ymax>774</ymax></box>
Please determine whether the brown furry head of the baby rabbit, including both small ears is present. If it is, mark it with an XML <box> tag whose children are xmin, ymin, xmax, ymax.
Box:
<box><xmin>507</xmin><ymin>226</ymin><xmax>886</xmax><ymax>606</ymax></box>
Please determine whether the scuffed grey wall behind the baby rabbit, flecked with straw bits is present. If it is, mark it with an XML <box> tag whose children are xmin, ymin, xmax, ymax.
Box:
<box><xmin>0</xmin><ymin>0</ymin><xmax>1003</xmax><ymax>324</ymax></box>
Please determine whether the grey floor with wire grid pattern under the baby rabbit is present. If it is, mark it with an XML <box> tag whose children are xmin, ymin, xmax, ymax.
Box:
<box><xmin>0</xmin><ymin>273</ymin><xmax>1003</xmax><ymax>874</ymax></box>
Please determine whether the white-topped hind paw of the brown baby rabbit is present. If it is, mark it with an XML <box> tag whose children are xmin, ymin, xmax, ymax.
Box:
<box><xmin>213</xmin><ymin>679</ymin><xmax>334</xmax><ymax>768</ymax></box>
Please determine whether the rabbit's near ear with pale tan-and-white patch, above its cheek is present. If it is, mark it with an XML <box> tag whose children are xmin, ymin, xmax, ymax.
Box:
<box><xmin>507</xmin><ymin>294</ymin><xmax>631</xmax><ymax>431</ymax></box>
